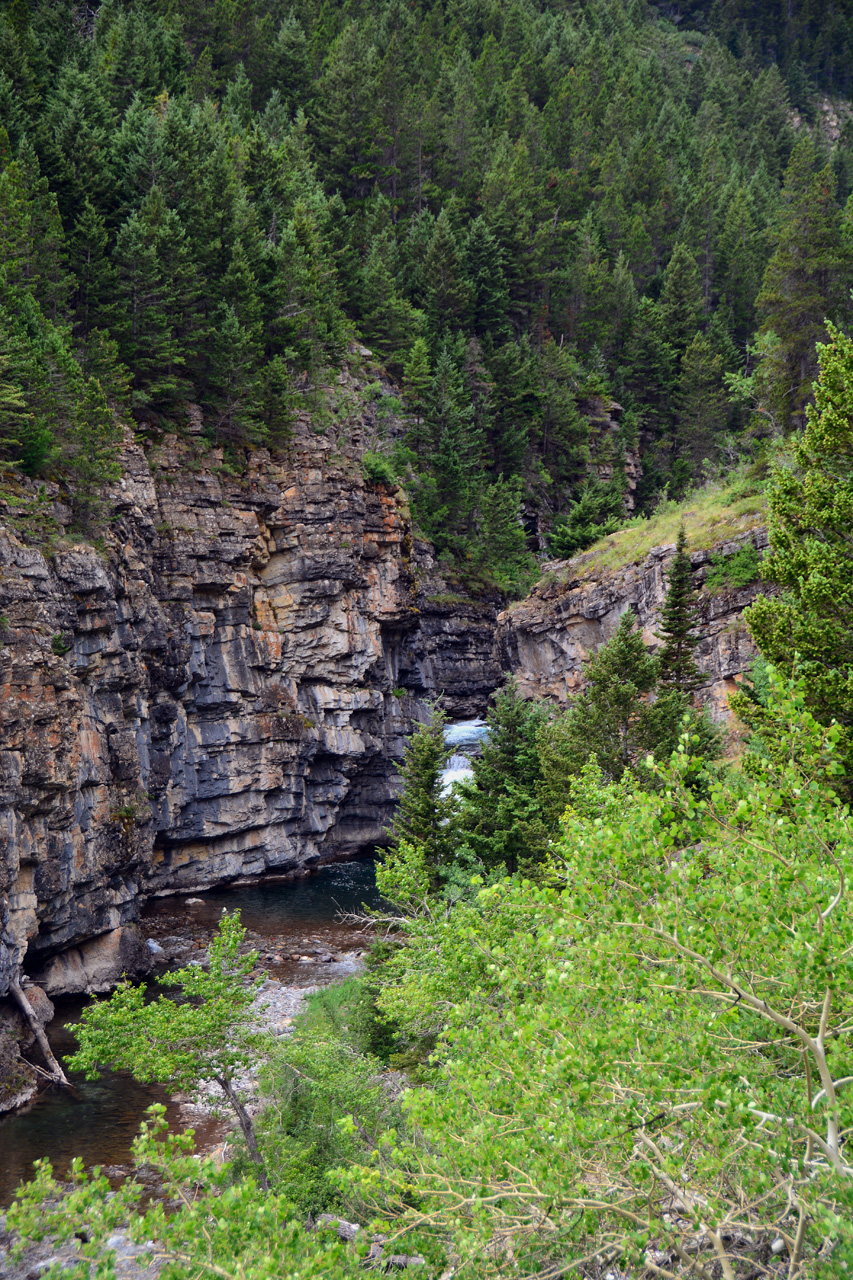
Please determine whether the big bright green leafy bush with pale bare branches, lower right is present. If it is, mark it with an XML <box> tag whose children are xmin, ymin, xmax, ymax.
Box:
<box><xmin>348</xmin><ymin>680</ymin><xmax>853</xmax><ymax>1280</ymax></box>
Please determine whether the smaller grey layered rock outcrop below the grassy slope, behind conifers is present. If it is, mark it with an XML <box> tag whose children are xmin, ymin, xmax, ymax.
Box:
<box><xmin>497</xmin><ymin>529</ymin><xmax>767</xmax><ymax>721</ymax></box>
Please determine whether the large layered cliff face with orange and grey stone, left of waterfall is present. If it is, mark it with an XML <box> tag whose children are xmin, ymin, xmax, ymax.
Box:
<box><xmin>0</xmin><ymin>374</ymin><xmax>501</xmax><ymax>993</ymax></box>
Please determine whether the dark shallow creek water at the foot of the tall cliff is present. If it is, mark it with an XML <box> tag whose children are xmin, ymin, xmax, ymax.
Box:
<box><xmin>0</xmin><ymin>860</ymin><xmax>379</xmax><ymax>1207</ymax></box>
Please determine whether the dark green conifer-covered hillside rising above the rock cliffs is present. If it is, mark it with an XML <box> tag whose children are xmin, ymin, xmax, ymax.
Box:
<box><xmin>0</xmin><ymin>0</ymin><xmax>853</xmax><ymax>589</ymax></box>
